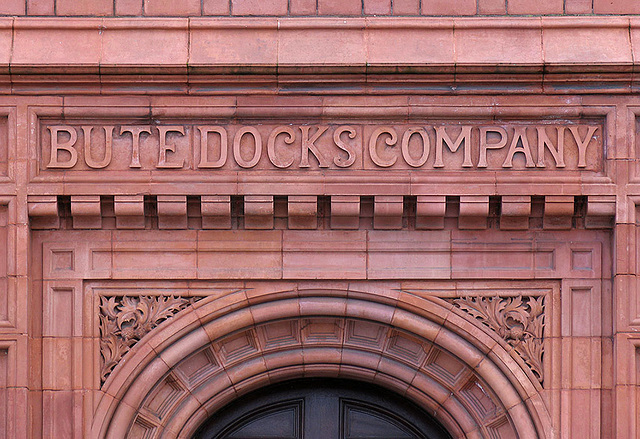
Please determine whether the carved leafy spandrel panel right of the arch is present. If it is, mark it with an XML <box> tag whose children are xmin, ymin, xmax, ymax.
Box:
<box><xmin>452</xmin><ymin>296</ymin><xmax>545</xmax><ymax>383</ymax></box>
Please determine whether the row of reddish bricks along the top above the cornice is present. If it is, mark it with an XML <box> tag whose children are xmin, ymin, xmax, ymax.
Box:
<box><xmin>0</xmin><ymin>0</ymin><xmax>640</xmax><ymax>17</ymax></box>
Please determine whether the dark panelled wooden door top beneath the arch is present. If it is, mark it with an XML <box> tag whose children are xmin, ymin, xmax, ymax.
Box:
<box><xmin>195</xmin><ymin>379</ymin><xmax>450</xmax><ymax>439</ymax></box>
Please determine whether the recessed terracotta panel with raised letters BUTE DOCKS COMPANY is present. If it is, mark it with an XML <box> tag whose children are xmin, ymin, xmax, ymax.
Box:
<box><xmin>41</xmin><ymin>121</ymin><xmax>603</xmax><ymax>172</ymax></box>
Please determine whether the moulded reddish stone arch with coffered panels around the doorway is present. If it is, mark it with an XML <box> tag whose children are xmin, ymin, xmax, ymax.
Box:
<box><xmin>92</xmin><ymin>289</ymin><xmax>551</xmax><ymax>438</ymax></box>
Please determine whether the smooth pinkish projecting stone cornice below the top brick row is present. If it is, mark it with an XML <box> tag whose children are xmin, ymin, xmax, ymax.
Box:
<box><xmin>0</xmin><ymin>17</ymin><xmax>640</xmax><ymax>82</ymax></box>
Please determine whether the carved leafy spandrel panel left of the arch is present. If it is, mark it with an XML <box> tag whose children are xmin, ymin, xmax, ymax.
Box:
<box><xmin>100</xmin><ymin>296</ymin><xmax>200</xmax><ymax>383</ymax></box>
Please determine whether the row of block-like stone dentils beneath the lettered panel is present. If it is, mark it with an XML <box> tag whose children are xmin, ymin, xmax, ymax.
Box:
<box><xmin>29</xmin><ymin>195</ymin><xmax>615</xmax><ymax>230</ymax></box>
